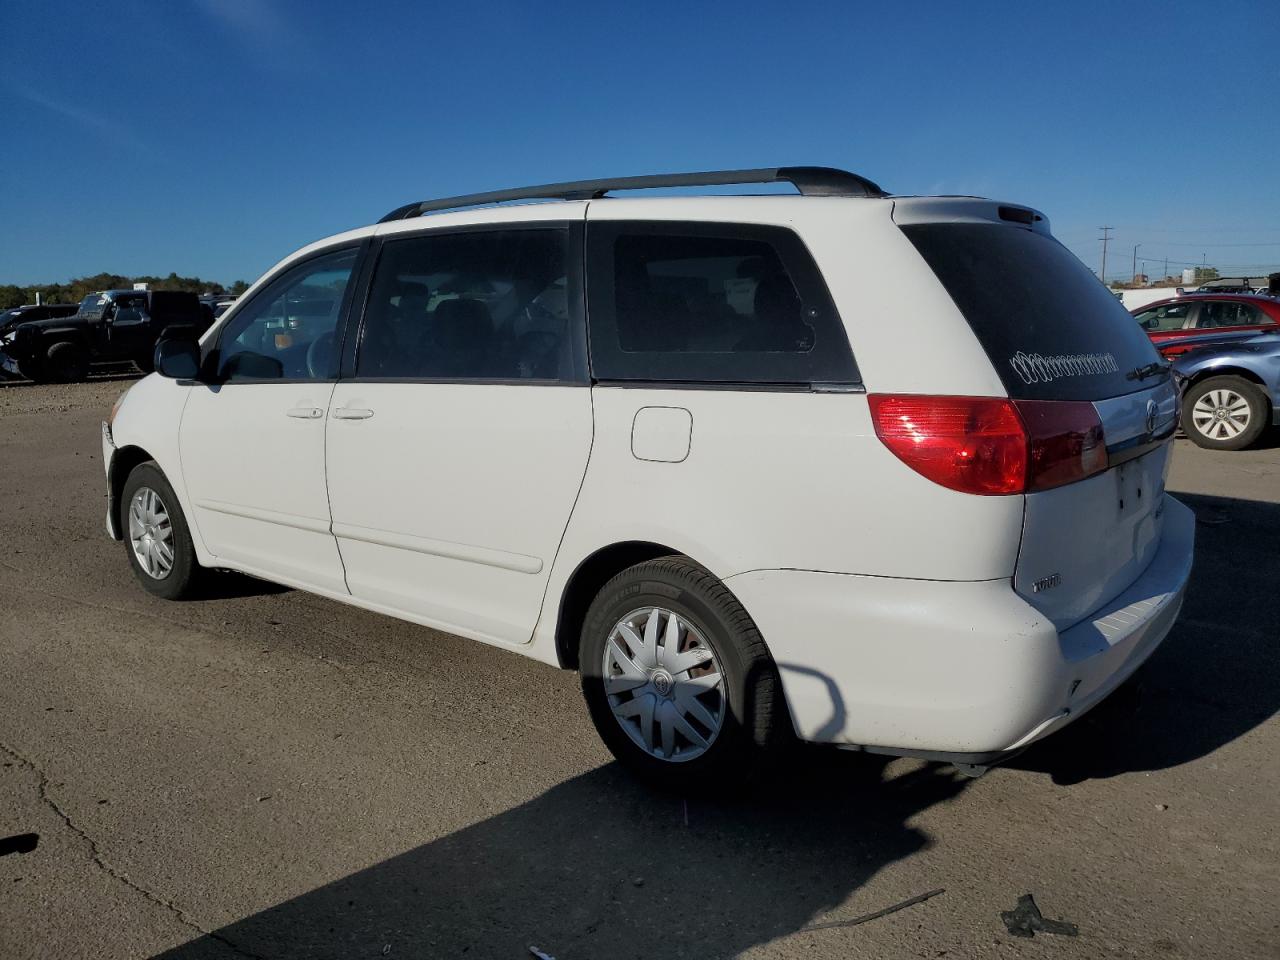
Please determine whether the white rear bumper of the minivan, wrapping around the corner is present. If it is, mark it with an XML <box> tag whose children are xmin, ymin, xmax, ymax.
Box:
<box><xmin>727</xmin><ymin>497</ymin><xmax>1196</xmax><ymax>762</ymax></box>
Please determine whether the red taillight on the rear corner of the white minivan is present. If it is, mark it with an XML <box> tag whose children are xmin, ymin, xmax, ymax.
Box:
<box><xmin>867</xmin><ymin>393</ymin><xmax>1107</xmax><ymax>497</ymax></box>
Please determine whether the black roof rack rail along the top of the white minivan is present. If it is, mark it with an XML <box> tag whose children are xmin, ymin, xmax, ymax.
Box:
<box><xmin>378</xmin><ymin>166</ymin><xmax>888</xmax><ymax>223</ymax></box>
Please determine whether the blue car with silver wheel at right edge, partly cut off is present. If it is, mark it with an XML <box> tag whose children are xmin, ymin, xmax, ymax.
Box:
<box><xmin>1174</xmin><ymin>332</ymin><xmax>1280</xmax><ymax>451</ymax></box>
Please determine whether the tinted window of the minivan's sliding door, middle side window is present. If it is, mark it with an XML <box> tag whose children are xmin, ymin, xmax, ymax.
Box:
<box><xmin>356</xmin><ymin>227</ymin><xmax>584</xmax><ymax>381</ymax></box>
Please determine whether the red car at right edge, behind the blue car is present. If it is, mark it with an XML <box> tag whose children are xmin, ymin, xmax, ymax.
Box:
<box><xmin>1129</xmin><ymin>293</ymin><xmax>1280</xmax><ymax>357</ymax></box>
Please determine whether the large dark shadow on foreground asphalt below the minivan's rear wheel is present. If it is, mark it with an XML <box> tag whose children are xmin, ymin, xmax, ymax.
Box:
<box><xmin>149</xmin><ymin>751</ymin><xmax>965</xmax><ymax>960</ymax></box>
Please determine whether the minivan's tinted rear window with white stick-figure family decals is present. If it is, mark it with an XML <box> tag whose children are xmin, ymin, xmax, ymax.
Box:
<box><xmin>901</xmin><ymin>223</ymin><xmax>1160</xmax><ymax>401</ymax></box>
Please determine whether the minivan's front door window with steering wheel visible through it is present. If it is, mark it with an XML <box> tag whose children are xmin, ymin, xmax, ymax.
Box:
<box><xmin>218</xmin><ymin>250</ymin><xmax>357</xmax><ymax>381</ymax></box>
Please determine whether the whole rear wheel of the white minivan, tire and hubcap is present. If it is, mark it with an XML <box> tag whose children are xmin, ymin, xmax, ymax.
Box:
<box><xmin>579</xmin><ymin>557</ymin><xmax>790</xmax><ymax>790</ymax></box>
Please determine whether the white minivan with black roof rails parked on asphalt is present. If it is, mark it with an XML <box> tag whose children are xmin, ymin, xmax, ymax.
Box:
<box><xmin>102</xmin><ymin>168</ymin><xmax>1193</xmax><ymax>786</ymax></box>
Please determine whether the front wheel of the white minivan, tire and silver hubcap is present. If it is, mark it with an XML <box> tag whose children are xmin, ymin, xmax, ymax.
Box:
<box><xmin>120</xmin><ymin>461</ymin><xmax>204</xmax><ymax>600</ymax></box>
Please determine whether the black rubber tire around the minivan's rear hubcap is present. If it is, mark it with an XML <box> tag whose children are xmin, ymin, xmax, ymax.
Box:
<box><xmin>579</xmin><ymin>557</ymin><xmax>792</xmax><ymax>791</ymax></box>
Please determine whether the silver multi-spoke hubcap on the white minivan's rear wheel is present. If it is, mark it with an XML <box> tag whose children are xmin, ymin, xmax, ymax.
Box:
<box><xmin>604</xmin><ymin>607</ymin><xmax>726</xmax><ymax>763</ymax></box>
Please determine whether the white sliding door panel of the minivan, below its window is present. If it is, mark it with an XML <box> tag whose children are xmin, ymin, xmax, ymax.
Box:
<box><xmin>326</xmin><ymin>383</ymin><xmax>591</xmax><ymax>644</ymax></box>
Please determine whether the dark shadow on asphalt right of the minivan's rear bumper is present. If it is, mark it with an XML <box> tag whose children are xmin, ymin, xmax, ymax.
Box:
<box><xmin>1010</xmin><ymin>493</ymin><xmax>1280</xmax><ymax>783</ymax></box>
